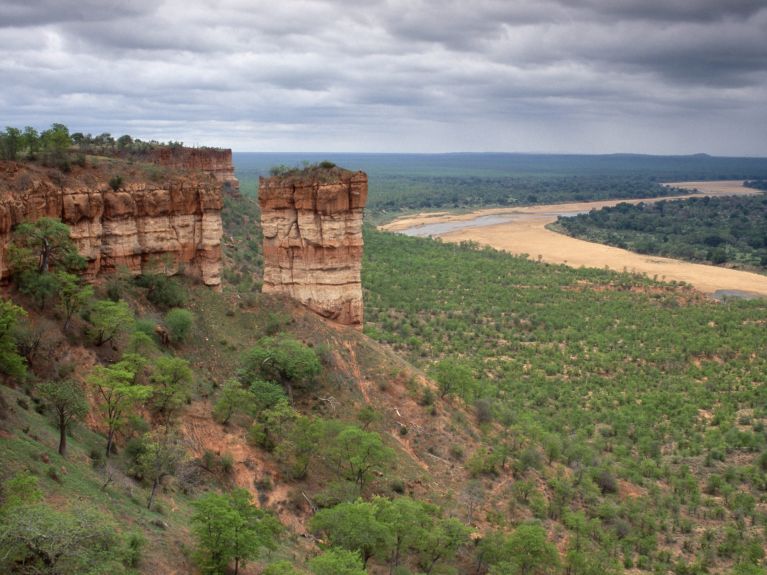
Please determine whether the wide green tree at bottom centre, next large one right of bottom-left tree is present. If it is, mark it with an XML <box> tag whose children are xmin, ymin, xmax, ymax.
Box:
<box><xmin>309</xmin><ymin>500</ymin><xmax>393</xmax><ymax>566</ymax></box>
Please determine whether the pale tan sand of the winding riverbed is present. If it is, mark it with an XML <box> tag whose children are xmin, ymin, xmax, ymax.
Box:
<box><xmin>382</xmin><ymin>181</ymin><xmax>767</xmax><ymax>296</ymax></box>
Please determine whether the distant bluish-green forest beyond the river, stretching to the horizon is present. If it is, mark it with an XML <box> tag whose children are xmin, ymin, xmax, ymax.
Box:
<box><xmin>234</xmin><ymin>153</ymin><xmax>767</xmax><ymax>218</ymax></box>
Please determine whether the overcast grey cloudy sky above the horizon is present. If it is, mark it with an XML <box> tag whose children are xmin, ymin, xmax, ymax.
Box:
<box><xmin>0</xmin><ymin>0</ymin><xmax>767</xmax><ymax>156</ymax></box>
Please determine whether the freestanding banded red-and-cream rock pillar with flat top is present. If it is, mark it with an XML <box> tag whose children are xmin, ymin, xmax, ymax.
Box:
<box><xmin>258</xmin><ymin>168</ymin><xmax>368</xmax><ymax>329</ymax></box>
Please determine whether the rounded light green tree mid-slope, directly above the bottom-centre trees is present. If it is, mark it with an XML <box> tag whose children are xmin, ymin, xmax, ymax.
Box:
<box><xmin>323</xmin><ymin>426</ymin><xmax>394</xmax><ymax>491</ymax></box>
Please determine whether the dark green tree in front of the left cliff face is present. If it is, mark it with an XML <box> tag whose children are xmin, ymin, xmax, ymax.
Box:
<box><xmin>9</xmin><ymin>217</ymin><xmax>85</xmax><ymax>274</ymax></box>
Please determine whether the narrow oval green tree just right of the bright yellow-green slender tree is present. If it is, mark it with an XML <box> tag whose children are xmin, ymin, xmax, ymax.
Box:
<box><xmin>149</xmin><ymin>355</ymin><xmax>194</xmax><ymax>429</ymax></box>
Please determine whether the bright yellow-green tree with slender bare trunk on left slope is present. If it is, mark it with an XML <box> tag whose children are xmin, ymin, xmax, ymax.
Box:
<box><xmin>87</xmin><ymin>361</ymin><xmax>152</xmax><ymax>457</ymax></box>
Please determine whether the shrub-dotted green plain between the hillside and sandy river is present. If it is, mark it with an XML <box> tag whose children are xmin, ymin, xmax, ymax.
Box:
<box><xmin>363</xmin><ymin>228</ymin><xmax>767</xmax><ymax>574</ymax></box>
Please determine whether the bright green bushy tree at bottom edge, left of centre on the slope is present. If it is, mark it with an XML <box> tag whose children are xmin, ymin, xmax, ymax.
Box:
<box><xmin>192</xmin><ymin>489</ymin><xmax>281</xmax><ymax>575</ymax></box>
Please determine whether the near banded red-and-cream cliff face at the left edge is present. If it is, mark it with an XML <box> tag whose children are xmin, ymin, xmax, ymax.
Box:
<box><xmin>0</xmin><ymin>158</ymin><xmax>222</xmax><ymax>287</ymax></box>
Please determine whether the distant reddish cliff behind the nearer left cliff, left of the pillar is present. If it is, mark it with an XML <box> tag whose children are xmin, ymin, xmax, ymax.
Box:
<box><xmin>150</xmin><ymin>146</ymin><xmax>240</xmax><ymax>195</ymax></box>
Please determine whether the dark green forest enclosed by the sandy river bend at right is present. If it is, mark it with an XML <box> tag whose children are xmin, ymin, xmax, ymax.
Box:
<box><xmin>556</xmin><ymin>195</ymin><xmax>767</xmax><ymax>270</ymax></box>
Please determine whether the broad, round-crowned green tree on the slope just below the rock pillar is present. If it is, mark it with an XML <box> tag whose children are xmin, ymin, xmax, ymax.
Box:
<box><xmin>240</xmin><ymin>335</ymin><xmax>322</xmax><ymax>403</ymax></box>
